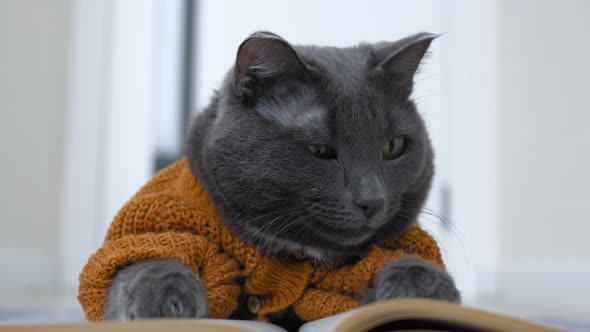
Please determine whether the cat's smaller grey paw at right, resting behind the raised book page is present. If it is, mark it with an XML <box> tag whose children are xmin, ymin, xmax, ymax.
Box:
<box><xmin>375</xmin><ymin>257</ymin><xmax>461</xmax><ymax>302</ymax></box>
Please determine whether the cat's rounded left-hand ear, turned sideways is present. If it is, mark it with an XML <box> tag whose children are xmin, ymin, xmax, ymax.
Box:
<box><xmin>233</xmin><ymin>32</ymin><xmax>305</xmax><ymax>97</ymax></box>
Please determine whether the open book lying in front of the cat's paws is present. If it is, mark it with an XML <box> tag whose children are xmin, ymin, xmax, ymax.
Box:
<box><xmin>0</xmin><ymin>299</ymin><xmax>556</xmax><ymax>332</ymax></box>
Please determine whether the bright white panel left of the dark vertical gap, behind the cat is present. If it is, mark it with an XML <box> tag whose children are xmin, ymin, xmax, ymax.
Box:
<box><xmin>59</xmin><ymin>0</ymin><xmax>182</xmax><ymax>289</ymax></box>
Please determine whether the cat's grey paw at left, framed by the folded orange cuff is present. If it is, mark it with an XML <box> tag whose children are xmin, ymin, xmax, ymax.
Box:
<box><xmin>105</xmin><ymin>260</ymin><xmax>207</xmax><ymax>320</ymax></box>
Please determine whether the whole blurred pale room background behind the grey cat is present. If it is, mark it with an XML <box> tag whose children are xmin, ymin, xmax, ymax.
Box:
<box><xmin>0</xmin><ymin>0</ymin><xmax>590</xmax><ymax>321</ymax></box>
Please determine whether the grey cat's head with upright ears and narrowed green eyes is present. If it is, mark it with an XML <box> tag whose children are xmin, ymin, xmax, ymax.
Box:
<box><xmin>187</xmin><ymin>32</ymin><xmax>436</xmax><ymax>259</ymax></box>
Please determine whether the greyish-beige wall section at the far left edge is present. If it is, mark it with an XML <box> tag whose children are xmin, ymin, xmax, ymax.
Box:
<box><xmin>0</xmin><ymin>0</ymin><xmax>69</xmax><ymax>292</ymax></box>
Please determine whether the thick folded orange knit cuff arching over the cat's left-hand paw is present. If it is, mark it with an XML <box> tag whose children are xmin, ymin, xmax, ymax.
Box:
<box><xmin>78</xmin><ymin>232</ymin><xmax>241</xmax><ymax>321</ymax></box>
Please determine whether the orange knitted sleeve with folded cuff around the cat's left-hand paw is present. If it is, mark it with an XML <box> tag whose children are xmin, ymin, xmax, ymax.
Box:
<box><xmin>78</xmin><ymin>190</ymin><xmax>242</xmax><ymax>321</ymax></box>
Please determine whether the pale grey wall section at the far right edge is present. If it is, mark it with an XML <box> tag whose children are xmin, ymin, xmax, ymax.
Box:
<box><xmin>497</xmin><ymin>0</ymin><xmax>590</xmax><ymax>309</ymax></box>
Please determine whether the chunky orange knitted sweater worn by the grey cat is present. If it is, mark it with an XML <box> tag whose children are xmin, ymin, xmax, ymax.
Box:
<box><xmin>78</xmin><ymin>159</ymin><xmax>443</xmax><ymax>321</ymax></box>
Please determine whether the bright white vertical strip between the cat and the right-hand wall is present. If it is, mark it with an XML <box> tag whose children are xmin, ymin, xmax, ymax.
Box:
<box><xmin>446</xmin><ymin>0</ymin><xmax>497</xmax><ymax>302</ymax></box>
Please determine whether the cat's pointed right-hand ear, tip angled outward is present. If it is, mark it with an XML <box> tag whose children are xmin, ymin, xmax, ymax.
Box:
<box><xmin>372</xmin><ymin>32</ymin><xmax>439</xmax><ymax>85</ymax></box>
